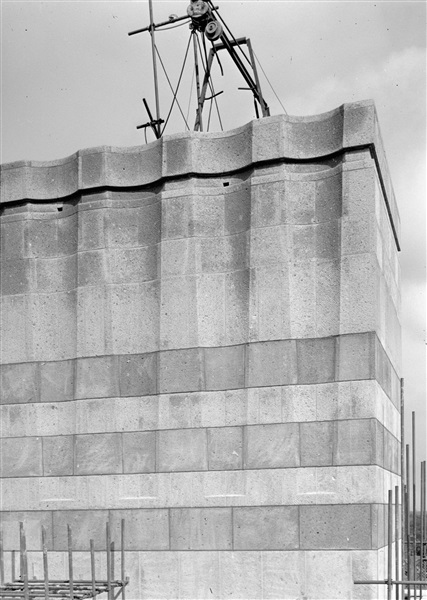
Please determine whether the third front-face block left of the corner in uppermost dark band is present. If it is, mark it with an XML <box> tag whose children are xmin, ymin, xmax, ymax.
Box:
<box><xmin>247</xmin><ymin>340</ymin><xmax>297</xmax><ymax>387</ymax></box>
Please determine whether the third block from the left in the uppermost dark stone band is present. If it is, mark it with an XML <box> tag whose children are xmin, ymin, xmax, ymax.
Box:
<box><xmin>75</xmin><ymin>356</ymin><xmax>119</xmax><ymax>398</ymax></box>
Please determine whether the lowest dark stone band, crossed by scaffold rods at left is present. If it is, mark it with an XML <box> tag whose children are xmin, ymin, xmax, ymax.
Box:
<box><xmin>2</xmin><ymin>504</ymin><xmax>394</xmax><ymax>551</ymax></box>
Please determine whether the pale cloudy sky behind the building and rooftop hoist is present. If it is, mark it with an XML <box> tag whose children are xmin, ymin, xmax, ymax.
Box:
<box><xmin>0</xmin><ymin>0</ymin><xmax>427</xmax><ymax>474</ymax></box>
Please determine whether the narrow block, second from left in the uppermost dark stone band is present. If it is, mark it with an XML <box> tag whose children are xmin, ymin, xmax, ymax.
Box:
<box><xmin>40</xmin><ymin>360</ymin><xmax>75</xmax><ymax>402</ymax></box>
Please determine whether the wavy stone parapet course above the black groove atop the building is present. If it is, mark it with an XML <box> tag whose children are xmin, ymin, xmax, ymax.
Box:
<box><xmin>0</xmin><ymin>100</ymin><xmax>400</xmax><ymax>248</ymax></box>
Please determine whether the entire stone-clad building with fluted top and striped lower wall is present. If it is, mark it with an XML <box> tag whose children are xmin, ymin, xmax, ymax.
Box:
<box><xmin>1</xmin><ymin>101</ymin><xmax>401</xmax><ymax>600</ymax></box>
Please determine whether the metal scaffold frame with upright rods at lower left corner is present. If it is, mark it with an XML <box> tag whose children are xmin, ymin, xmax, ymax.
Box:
<box><xmin>0</xmin><ymin>519</ymin><xmax>129</xmax><ymax>600</ymax></box>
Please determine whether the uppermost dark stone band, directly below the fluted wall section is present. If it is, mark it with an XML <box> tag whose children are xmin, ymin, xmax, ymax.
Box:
<box><xmin>1</xmin><ymin>332</ymin><xmax>400</xmax><ymax>409</ymax></box>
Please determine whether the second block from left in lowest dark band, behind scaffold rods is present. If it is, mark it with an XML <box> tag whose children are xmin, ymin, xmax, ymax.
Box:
<box><xmin>52</xmin><ymin>510</ymin><xmax>108</xmax><ymax>551</ymax></box>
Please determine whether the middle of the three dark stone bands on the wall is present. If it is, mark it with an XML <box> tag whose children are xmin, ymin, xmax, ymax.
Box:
<box><xmin>0</xmin><ymin>419</ymin><xmax>400</xmax><ymax>477</ymax></box>
